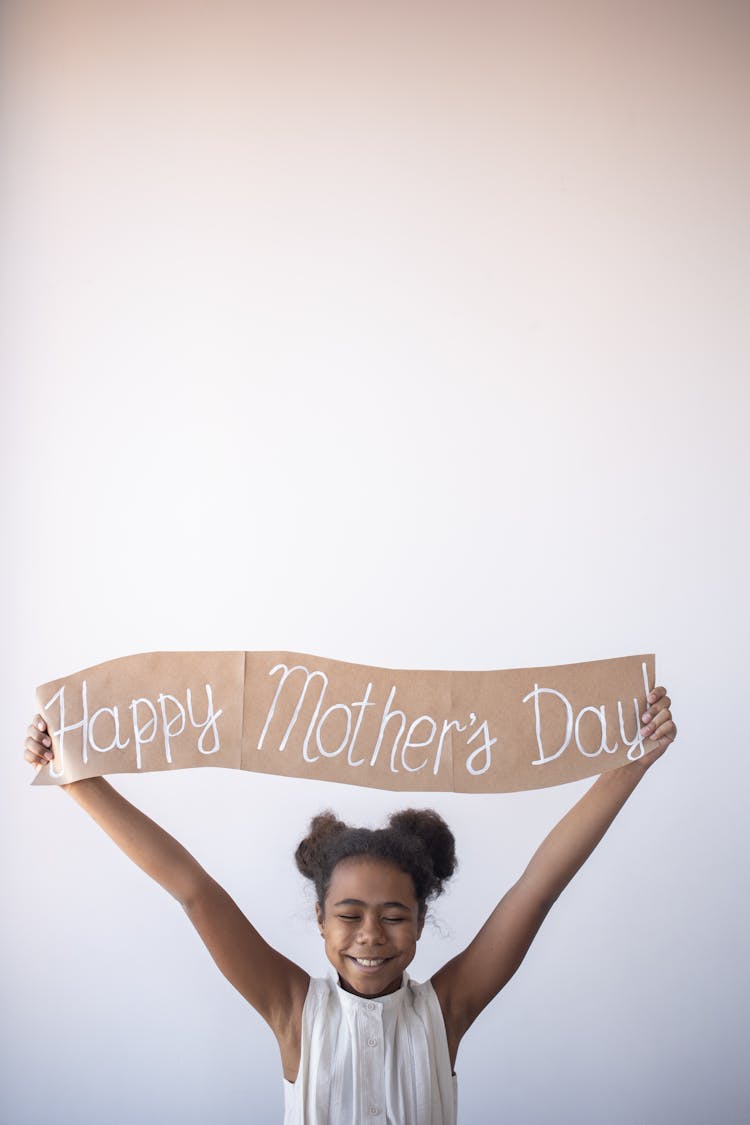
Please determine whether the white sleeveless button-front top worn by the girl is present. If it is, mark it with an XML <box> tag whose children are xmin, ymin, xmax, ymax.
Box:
<box><xmin>283</xmin><ymin>973</ymin><xmax>457</xmax><ymax>1125</ymax></box>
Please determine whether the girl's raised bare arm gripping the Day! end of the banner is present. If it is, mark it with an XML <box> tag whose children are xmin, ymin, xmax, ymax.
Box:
<box><xmin>433</xmin><ymin>687</ymin><xmax>677</xmax><ymax>1058</ymax></box>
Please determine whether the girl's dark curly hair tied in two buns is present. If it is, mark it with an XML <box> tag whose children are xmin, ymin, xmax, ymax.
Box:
<box><xmin>295</xmin><ymin>809</ymin><xmax>458</xmax><ymax>917</ymax></box>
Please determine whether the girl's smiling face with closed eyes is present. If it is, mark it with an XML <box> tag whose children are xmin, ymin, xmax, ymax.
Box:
<box><xmin>315</xmin><ymin>856</ymin><xmax>424</xmax><ymax>997</ymax></box>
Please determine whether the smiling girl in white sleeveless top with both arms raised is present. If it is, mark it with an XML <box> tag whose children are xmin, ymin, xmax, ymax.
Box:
<box><xmin>24</xmin><ymin>687</ymin><xmax>677</xmax><ymax>1125</ymax></box>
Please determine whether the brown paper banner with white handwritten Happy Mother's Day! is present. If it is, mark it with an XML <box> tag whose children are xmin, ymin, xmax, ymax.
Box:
<box><xmin>34</xmin><ymin>653</ymin><xmax>654</xmax><ymax>793</ymax></box>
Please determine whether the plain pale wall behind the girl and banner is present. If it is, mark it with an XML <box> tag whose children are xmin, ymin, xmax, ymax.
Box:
<box><xmin>0</xmin><ymin>0</ymin><xmax>750</xmax><ymax>1125</ymax></box>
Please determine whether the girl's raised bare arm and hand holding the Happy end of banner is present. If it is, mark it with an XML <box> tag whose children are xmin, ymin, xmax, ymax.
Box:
<box><xmin>24</xmin><ymin>714</ymin><xmax>309</xmax><ymax>1053</ymax></box>
